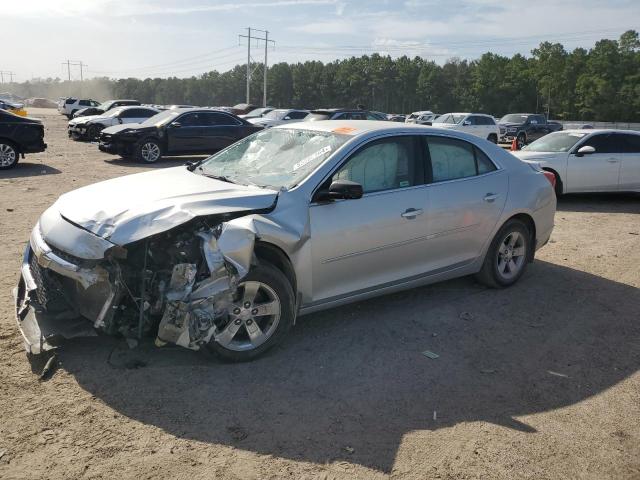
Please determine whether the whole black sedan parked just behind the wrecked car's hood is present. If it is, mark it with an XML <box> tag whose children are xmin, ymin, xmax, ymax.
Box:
<box><xmin>98</xmin><ymin>108</ymin><xmax>262</xmax><ymax>163</ymax></box>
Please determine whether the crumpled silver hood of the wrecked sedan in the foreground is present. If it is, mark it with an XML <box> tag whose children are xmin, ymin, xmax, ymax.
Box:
<box><xmin>53</xmin><ymin>166</ymin><xmax>278</xmax><ymax>245</ymax></box>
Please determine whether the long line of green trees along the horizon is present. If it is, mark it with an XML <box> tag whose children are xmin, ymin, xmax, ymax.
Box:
<box><xmin>6</xmin><ymin>30</ymin><xmax>640</xmax><ymax>122</ymax></box>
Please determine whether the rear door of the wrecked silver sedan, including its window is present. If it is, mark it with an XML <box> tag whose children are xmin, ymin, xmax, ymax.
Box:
<box><xmin>425</xmin><ymin>135</ymin><xmax>509</xmax><ymax>271</ymax></box>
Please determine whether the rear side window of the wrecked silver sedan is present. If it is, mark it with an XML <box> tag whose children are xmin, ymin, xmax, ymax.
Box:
<box><xmin>427</xmin><ymin>137</ymin><xmax>496</xmax><ymax>182</ymax></box>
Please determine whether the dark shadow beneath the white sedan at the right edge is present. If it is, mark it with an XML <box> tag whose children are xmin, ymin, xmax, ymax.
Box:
<box><xmin>558</xmin><ymin>193</ymin><xmax>640</xmax><ymax>213</ymax></box>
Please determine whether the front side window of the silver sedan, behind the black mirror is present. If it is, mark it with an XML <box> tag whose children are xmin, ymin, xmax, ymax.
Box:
<box><xmin>332</xmin><ymin>136</ymin><xmax>421</xmax><ymax>193</ymax></box>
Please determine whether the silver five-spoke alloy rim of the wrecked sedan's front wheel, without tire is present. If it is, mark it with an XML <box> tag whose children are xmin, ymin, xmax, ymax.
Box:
<box><xmin>215</xmin><ymin>281</ymin><xmax>281</xmax><ymax>351</ymax></box>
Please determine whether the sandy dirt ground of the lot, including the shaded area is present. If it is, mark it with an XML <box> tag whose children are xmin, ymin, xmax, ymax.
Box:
<box><xmin>0</xmin><ymin>109</ymin><xmax>640</xmax><ymax>480</ymax></box>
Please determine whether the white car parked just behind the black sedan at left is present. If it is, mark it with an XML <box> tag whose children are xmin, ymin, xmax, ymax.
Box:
<box><xmin>68</xmin><ymin>106</ymin><xmax>160</xmax><ymax>140</ymax></box>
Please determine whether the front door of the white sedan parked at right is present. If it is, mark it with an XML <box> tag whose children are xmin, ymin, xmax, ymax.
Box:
<box><xmin>564</xmin><ymin>133</ymin><xmax>622</xmax><ymax>193</ymax></box>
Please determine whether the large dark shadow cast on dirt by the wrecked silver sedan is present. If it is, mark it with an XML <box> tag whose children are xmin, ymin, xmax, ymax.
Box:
<box><xmin>60</xmin><ymin>261</ymin><xmax>640</xmax><ymax>472</ymax></box>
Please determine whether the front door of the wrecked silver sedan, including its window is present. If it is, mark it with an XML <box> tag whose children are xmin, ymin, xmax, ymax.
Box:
<box><xmin>309</xmin><ymin>135</ymin><xmax>428</xmax><ymax>302</ymax></box>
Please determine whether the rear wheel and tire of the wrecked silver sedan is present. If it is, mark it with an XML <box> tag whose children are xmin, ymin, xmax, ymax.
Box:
<box><xmin>476</xmin><ymin>219</ymin><xmax>533</xmax><ymax>288</ymax></box>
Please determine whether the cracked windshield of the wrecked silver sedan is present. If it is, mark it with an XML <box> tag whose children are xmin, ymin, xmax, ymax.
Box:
<box><xmin>200</xmin><ymin>128</ymin><xmax>350</xmax><ymax>189</ymax></box>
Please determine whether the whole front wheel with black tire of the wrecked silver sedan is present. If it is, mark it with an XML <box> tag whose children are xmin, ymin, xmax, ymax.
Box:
<box><xmin>206</xmin><ymin>260</ymin><xmax>295</xmax><ymax>362</ymax></box>
